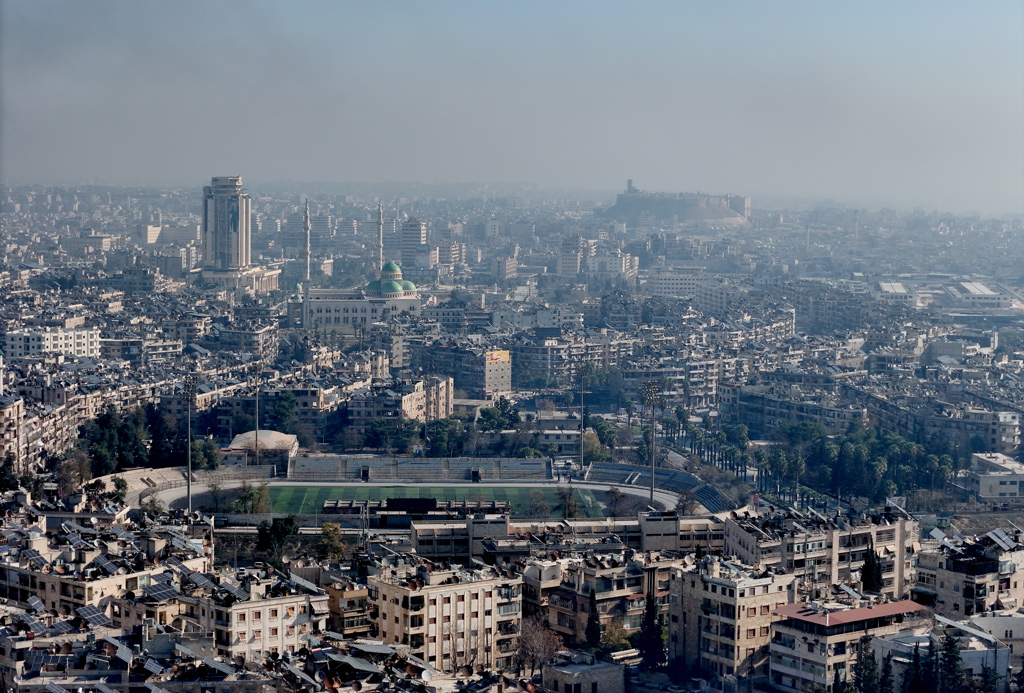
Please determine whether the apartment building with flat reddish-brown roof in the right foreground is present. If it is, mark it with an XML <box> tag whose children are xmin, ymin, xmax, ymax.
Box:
<box><xmin>769</xmin><ymin>600</ymin><xmax>930</xmax><ymax>693</ymax></box>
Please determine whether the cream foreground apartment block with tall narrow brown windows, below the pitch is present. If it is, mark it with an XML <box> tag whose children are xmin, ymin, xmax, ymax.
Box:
<box><xmin>367</xmin><ymin>555</ymin><xmax>522</xmax><ymax>673</ymax></box>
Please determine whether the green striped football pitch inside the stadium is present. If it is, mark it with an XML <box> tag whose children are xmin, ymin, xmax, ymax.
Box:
<box><xmin>267</xmin><ymin>484</ymin><xmax>604</xmax><ymax>517</ymax></box>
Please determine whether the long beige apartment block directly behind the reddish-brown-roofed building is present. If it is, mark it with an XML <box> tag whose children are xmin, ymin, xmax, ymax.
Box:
<box><xmin>725</xmin><ymin>513</ymin><xmax>918</xmax><ymax>599</ymax></box>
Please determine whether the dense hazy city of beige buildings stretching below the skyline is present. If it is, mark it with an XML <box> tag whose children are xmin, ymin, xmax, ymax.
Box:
<box><xmin>0</xmin><ymin>172</ymin><xmax>1024</xmax><ymax>693</ymax></box>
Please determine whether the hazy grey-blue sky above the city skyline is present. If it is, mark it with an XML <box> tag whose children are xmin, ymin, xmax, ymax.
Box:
<box><xmin>0</xmin><ymin>0</ymin><xmax>1024</xmax><ymax>213</ymax></box>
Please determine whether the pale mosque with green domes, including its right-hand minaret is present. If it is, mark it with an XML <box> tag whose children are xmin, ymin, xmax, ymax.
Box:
<box><xmin>302</xmin><ymin>205</ymin><xmax>422</xmax><ymax>334</ymax></box>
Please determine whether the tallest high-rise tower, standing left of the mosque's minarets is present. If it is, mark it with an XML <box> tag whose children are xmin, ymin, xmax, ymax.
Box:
<box><xmin>203</xmin><ymin>176</ymin><xmax>251</xmax><ymax>270</ymax></box>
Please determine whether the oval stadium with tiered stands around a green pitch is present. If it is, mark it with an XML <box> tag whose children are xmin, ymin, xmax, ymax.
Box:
<box><xmin>132</xmin><ymin>454</ymin><xmax>735</xmax><ymax>521</ymax></box>
